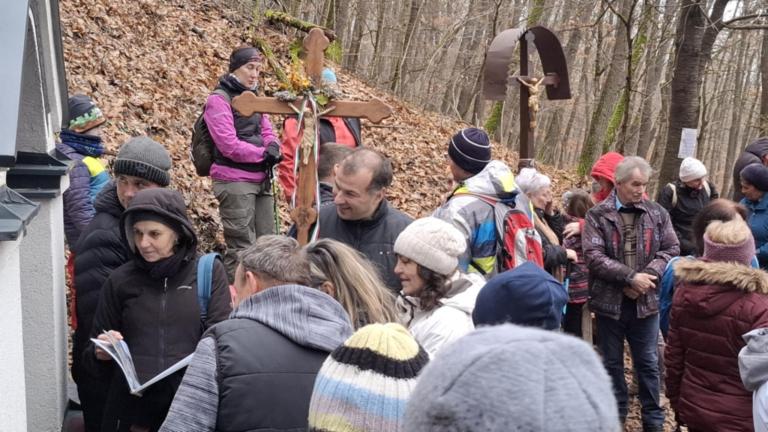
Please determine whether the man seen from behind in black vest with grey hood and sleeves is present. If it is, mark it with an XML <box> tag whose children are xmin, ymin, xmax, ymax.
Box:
<box><xmin>160</xmin><ymin>235</ymin><xmax>352</xmax><ymax>432</ymax></box>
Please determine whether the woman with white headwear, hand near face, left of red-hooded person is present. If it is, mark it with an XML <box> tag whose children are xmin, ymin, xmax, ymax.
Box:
<box><xmin>515</xmin><ymin>168</ymin><xmax>577</xmax><ymax>282</ymax></box>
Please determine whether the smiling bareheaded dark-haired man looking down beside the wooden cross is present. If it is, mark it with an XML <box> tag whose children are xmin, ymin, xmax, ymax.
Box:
<box><xmin>319</xmin><ymin>148</ymin><xmax>413</xmax><ymax>293</ymax></box>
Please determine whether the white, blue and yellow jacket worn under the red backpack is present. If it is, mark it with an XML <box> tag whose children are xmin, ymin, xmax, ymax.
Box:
<box><xmin>432</xmin><ymin>161</ymin><xmax>518</xmax><ymax>278</ymax></box>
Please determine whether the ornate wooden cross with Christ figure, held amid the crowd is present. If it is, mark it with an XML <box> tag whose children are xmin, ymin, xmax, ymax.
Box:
<box><xmin>232</xmin><ymin>27</ymin><xmax>392</xmax><ymax>246</ymax></box>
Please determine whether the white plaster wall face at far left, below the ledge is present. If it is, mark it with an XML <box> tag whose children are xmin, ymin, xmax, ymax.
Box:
<box><xmin>0</xmin><ymin>236</ymin><xmax>31</xmax><ymax>431</ymax></box>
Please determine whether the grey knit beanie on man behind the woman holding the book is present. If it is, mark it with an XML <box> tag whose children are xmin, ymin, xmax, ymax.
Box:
<box><xmin>114</xmin><ymin>136</ymin><xmax>171</xmax><ymax>186</ymax></box>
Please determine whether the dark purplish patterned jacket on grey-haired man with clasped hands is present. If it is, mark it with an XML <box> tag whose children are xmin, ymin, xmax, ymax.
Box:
<box><xmin>582</xmin><ymin>191</ymin><xmax>680</xmax><ymax>319</ymax></box>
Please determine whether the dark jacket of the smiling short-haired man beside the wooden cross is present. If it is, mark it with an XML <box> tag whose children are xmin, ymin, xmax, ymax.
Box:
<box><xmin>319</xmin><ymin>200</ymin><xmax>413</xmax><ymax>294</ymax></box>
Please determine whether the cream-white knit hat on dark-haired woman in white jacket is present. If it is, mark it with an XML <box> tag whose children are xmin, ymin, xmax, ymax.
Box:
<box><xmin>395</xmin><ymin>217</ymin><xmax>467</xmax><ymax>276</ymax></box>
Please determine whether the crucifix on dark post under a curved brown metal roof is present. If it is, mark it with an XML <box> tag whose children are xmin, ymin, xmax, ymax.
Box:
<box><xmin>483</xmin><ymin>26</ymin><xmax>571</xmax><ymax>170</ymax></box>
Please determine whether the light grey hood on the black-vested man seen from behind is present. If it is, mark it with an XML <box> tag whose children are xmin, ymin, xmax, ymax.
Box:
<box><xmin>230</xmin><ymin>285</ymin><xmax>352</xmax><ymax>352</ymax></box>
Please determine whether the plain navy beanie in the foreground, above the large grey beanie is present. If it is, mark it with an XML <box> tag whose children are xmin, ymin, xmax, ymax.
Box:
<box><xmin>472</xmin><ymin>262</ymin><xmax>568</xmax><ymax>330</ymax></box>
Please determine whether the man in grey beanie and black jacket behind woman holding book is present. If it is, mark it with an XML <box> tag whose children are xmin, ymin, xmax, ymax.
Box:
<box><xmin>71</xmin><ymin>136</ymin><xmax>171</xmax><ymax>431</ymax></box>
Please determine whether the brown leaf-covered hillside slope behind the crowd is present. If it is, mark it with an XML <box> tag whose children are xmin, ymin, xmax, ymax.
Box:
<box><xmin>60</xmin><ymin>0</ymin><xmax>674</xmax><ymax>431</ymax></box>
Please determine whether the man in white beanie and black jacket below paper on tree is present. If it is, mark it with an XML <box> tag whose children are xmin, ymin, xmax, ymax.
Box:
<box><xmin>658</xmin><ymin>157</ymin><xmax>719</xmax><ymax>256</ymax></box>
